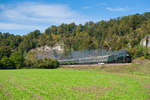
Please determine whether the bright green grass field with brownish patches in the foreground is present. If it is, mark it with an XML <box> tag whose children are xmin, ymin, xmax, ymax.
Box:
<box><xmin>0</xmin><ymin>62</ymin><xmax>150</xmax><ymax>100</ymax></box>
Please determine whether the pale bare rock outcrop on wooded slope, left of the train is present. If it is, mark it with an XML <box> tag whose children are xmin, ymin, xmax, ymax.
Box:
<box><xmin>30</xmin><ymin>44</ymin><xmax>64</xmax><ymax>59</ymax></box>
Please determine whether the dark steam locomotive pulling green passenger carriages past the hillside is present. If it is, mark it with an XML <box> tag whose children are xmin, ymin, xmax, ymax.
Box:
<box><xmin>58</xmin><ymin>50</ymin><xmax>132</xmax><ymax>65</ymax></box>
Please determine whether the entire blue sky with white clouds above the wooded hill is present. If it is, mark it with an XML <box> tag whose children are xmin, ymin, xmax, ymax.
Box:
<box><xmin>0</xmin><ymin>0</ymin><xmax>150</xmax><ymax>35</ymax></box>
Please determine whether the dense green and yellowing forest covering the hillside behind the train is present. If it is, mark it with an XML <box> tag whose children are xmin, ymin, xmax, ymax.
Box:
<box><xmin>0</xmin><ymin>12</ymin><xmax>150</xmax><ymax>69</ymax></box>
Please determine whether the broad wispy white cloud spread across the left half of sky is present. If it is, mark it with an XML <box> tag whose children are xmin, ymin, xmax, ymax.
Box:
<box><xmin>0</xmin><ymin>2</ymin><xmax>88</xmax><ymax>30</ymax></box>
